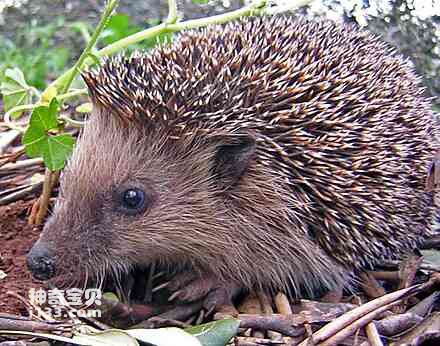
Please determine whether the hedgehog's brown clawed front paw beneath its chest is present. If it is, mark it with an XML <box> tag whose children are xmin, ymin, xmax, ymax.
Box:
<box><xmin>168</xmin><ymin>272</ymin><xmax>241</xmax><ymax>314</ymax></box>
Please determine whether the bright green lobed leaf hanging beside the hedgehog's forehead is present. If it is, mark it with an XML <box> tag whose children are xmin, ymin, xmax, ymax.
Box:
<box><xmin>22</xmin><ymin>98</ymin><xmax>75</xmax><ymax>171</ymax></box>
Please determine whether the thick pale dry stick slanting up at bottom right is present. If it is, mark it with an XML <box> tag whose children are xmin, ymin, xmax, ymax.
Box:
<box><xmin>300</xmin><ymin>285</ymin><xmax>420</xmax><ymax>346</ymax></box>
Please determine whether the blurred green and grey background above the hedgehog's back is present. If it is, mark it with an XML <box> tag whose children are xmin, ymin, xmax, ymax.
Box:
<box><xmin>0</xmin><ymin>0</ymin><xmax>440</xmax><ymax>111</ymax></box>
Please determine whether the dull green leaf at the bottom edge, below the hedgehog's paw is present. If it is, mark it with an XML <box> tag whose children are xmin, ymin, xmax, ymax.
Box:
<box><xmin>185</xmin><ymin>318</ymin><xmax>240</xmax><ymax>346</ymax></box>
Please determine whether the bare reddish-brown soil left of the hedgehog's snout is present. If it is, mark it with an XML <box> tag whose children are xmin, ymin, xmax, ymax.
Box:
<box><xmin>0</xmin><ymin>200</ymin><xmax>42</xmax><ymax>315</ymax></box>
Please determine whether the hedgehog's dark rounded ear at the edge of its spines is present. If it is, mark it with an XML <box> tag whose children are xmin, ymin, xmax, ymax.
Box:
<box><xmin>213</xmin><ymin>135</ymin><xmax>256</xmax><ymax>191</ymax></box>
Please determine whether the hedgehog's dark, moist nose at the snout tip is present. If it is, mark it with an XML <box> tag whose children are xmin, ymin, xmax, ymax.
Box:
<box><xmin>26</xmin><ymin>241</ymin><xmax>55</xmax><ymax>280</ymax></box>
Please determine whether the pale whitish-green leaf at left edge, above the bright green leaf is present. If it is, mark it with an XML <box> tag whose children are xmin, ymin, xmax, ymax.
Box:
<box><xmin>0</xmin><ymin>67</ymin><xmax>32</xmax><ymax>118</ymax></box>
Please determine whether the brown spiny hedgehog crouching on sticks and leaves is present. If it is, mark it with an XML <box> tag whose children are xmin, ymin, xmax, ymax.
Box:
<box><xmin>27</xmin><ymin>16</ymin><xmax>438</xmax><ymax>308</ymax></box>
